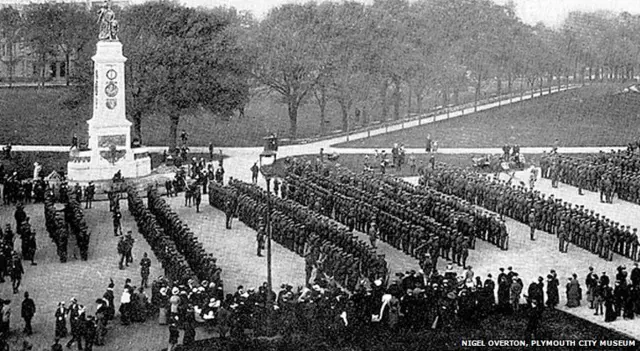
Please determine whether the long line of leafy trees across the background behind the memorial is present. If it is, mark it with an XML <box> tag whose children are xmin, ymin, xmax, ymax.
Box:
<box><xmin>0</xmin><ymin>0</ymin><xmax>640</xmax><ymax>143</ymax></box>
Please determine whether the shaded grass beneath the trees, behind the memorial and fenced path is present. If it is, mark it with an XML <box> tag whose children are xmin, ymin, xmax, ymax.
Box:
<box><xmin>0</xmin><ymin>78</ymin><xmax>564</xmax><ymax>147</ymax></box>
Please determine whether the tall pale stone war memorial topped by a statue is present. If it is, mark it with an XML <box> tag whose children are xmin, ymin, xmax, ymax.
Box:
<box><xmin>67</xmin><ymin>2</ymin><xmax>151</xmax><ymax>183</ymax></box>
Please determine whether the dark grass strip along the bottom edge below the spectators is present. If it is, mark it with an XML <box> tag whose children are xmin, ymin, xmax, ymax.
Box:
<box><xmin>178</xmin><ymin>309</ymin><xmax>638</xmax><ymax>351</ymax></box>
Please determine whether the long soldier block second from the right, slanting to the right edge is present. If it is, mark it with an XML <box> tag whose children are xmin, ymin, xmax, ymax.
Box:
<box><xmin>425</xmin><ymin>166</ymin><xmax>638</xmax><ymax>260</ymax></box>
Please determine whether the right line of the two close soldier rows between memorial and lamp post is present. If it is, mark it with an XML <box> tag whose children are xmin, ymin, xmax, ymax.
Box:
<box><xmin>147</xmin><ymin>189</ymin><xmax>221</xmax><ymax>283</ymax></box>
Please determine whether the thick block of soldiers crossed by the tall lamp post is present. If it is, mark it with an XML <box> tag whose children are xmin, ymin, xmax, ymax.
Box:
<box><xmin>210</xmin><ymin>180</ymin><xmax>388</xmax><ymax>290</ymax></box>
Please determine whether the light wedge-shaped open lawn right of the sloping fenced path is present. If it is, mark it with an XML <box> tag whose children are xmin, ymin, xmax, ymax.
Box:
<box><xmin>338</xmin><ymin>84</ymin><xmax>640</xmax><ymax>148</ymax></box>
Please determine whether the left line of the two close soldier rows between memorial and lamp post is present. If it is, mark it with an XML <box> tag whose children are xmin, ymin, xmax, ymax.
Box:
<box><xmin>127</xmin><ymin>186</ymin><xmax>196</xmax><ymax>284</ymax></box>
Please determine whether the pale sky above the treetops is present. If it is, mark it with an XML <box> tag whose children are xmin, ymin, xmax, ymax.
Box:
<box><xmin>169</xmin><ymin>0</ymin><xmax>640</xmax><ymax>27</ymax></box>
